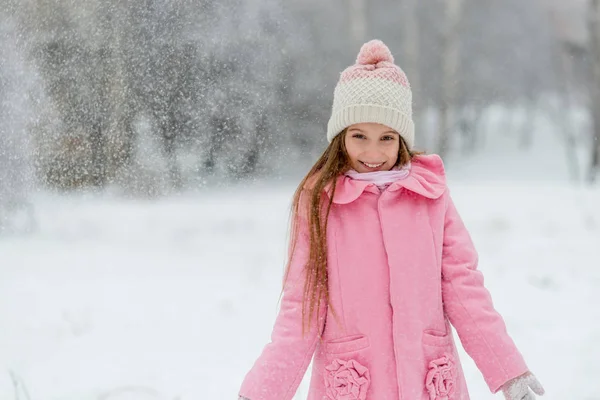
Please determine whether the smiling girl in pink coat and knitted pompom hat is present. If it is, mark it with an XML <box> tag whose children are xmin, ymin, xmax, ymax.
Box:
<box><xmin>239</xmin><ymin>40</ymin><xmax>544</xmax><ymax>400</ymax></box>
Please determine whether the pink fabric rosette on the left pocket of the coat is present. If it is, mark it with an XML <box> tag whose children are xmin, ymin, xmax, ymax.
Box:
<box><xmin>323</xmin><ymin>359</ymin><xmax>371</xmax><ymax>400</ymax></box>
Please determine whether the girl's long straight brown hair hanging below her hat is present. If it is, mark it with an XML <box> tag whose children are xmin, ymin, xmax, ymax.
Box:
<box><xmin>284</xmin><ymin>128</ymin><xmax>422</xmax><ymax>336</ymax></box>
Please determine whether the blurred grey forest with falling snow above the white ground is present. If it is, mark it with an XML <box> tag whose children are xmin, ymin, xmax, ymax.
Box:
<box><xmin>0</xmin><ymin>0</ymin><xmax>600</xmax><ymax>200</ymax></box>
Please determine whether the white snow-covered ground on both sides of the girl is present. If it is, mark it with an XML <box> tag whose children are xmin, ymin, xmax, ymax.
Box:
<box><xmin>0</xmin><ymin>170</ymin><xmax>600</xmax><ymax>400</ymax></box>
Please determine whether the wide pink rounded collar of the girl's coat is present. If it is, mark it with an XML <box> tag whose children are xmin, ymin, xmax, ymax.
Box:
<box><xmin>308</xmin><ymin>154</ymin><xmax>446</xmax><ymax>204</ymax></box>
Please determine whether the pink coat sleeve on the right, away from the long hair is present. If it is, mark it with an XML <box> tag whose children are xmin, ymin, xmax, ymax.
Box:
<box><xmin>442</xmin><ymin>192</ymin><xmax>527</xmax><ymax>393</ymax></box>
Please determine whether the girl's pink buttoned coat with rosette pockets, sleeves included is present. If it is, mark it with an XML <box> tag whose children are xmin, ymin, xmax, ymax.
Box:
<box><xmin>239</xmin><ymin>155</ymin><xmax>528</xmax><ymax>400</ymax></box>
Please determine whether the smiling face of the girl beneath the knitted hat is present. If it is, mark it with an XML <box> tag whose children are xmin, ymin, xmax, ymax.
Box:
<box><xmin>344</xmin><ymin>122</ymin><xmax>400</xmax><ymax>172</ymax></box>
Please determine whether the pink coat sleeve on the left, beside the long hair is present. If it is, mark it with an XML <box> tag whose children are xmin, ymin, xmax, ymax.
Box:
<box><xmin>239</xmin><ymin>208</ymin><xmax>327</xmax><ymax>400</ymax></box>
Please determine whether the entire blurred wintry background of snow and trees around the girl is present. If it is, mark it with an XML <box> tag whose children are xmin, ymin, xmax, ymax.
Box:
<box><xmin>0</xmin><ymin>0</ymin><xmax>600</xmax><ymax>400</ymax></box>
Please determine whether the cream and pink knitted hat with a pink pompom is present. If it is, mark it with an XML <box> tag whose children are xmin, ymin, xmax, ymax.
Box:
<box><xmin>327</xmin><ymin>40</ymin><xmax>415</xmax><ymax>149</ymax></box>
